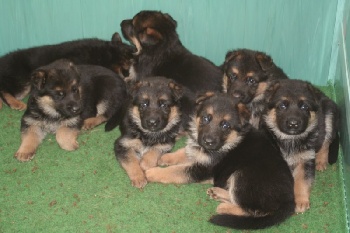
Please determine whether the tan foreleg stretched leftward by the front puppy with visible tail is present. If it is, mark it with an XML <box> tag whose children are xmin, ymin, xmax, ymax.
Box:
<box><xmin>146</xmin><ymin>165</ymin><xmax>190</xmax><ymax>184</ymax></box>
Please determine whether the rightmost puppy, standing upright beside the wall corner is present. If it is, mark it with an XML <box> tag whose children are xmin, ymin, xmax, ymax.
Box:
<box><xmin>263</xmin><ymin>80</ymin><xmax>339</xmax><ymax>212</ymax></box>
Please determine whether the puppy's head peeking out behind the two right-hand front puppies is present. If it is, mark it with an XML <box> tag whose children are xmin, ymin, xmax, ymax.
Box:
<box><xmin>223</xmin><ymin>49</ymin><xmax>275</xmax><ymax>104</ymax></box>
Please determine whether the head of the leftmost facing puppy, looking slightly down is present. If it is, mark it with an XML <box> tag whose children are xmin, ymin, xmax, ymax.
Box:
<box><xmin>31</xmin><ymin>60</ymin><xmax>82</xmax><ymax>117</ymax></box>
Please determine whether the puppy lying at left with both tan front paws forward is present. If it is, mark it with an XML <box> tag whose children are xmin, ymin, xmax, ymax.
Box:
<box><xmin>15</xmin><ymin>59</ymin><xmax>127</xmax><ymax>161</ymax></box>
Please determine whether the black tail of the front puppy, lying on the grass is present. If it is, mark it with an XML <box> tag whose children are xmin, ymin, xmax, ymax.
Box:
<box><xmin>209</xmin><ymin>202</ymin><xmax>295</xmax><ymax>230</ymax></box>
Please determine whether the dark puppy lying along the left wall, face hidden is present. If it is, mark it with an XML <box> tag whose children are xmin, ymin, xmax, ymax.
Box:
<box><xmin>0</xmin><ymin>33</ymin><xmax>134</xmax><ymax>110</ymax></box>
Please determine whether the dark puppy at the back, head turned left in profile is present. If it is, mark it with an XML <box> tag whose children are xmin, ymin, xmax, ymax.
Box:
<box><xmin>121</xmin><ymin>11</ymin><xmax>222</xmax><ymax>125</ymax></box>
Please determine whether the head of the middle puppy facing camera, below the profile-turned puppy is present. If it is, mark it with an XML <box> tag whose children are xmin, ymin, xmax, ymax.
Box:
<box><xmin>128</xmin><ymin>77</ymin><xmax>183</xmax><ymax>132</ymax></box>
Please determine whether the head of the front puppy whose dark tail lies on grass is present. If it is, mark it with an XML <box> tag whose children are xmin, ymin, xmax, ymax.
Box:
<box><xmin>191</xmin><ymin>92</ymin><xmax>250</xmax><ymax>152</ymax></box>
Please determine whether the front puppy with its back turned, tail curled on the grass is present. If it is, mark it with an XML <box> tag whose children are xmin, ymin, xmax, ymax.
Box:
<box><xmin>146</xmin><ymin>93</ymin><xmax>295</xmax><ymax>229</ymax></box>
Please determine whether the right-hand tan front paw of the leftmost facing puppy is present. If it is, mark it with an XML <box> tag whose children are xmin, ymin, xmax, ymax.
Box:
<box><xmin>56</xmin><ymin>126</ymin><xmax>79</xmax><ymax>151</ymax></box>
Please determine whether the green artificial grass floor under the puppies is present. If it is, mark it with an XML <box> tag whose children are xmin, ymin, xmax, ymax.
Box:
<box><xmin>0</xmin><ymin>88</ymin><xmax>347</xmax><ymax>233</ymax></box>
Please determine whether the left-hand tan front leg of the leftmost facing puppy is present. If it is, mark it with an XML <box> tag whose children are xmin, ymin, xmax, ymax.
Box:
<box><xmin>15</xmin><ymin>126</ymin><xmax>45</xmax><ymax>162</ymax></box>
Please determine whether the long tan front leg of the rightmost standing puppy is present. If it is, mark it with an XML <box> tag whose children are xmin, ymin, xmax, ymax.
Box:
<box><xmin>293</xmin><ymin>162</ymin><xmax>311</xmax><ymax>213</ymax></box>
